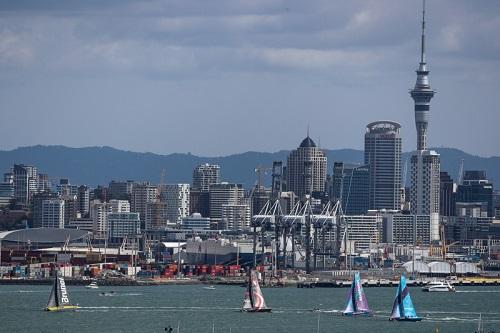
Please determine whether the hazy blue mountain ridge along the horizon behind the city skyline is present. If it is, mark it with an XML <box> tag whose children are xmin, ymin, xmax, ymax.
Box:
<box><xmin>0</xmin><ymin>145</ymin><xmax>500</xmax><ymax>188</ymax></box>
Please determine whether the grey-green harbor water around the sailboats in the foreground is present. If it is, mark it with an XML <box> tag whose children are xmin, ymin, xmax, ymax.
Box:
<box><xmin>0</xmin><ymin>285</ymin><xmax>500</xmax><ymax>333</ymax></box>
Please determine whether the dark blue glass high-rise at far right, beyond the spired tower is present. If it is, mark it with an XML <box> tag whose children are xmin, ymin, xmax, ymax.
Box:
<box><xmin>456</xmin><ymin>171</ymin><xmax>495</xmax><ymax>217</ymax></box>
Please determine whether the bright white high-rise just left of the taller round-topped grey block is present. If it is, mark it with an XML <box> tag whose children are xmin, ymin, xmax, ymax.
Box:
<box><xmin>163</xmin><ymin>184</ymin><xmax>190</xmax><ymax>226</ymax></box>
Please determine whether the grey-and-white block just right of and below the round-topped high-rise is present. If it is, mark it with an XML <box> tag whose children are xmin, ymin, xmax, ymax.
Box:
<box><xmin>210</xmin><ymin>182</ymin><xmax>245</xmax><ymax>227</ymax></box>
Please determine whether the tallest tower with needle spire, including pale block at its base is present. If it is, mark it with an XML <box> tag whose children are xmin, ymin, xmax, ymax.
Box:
<box><xmin>410</xmin><ymin>2</ymin><xmax>440</xmax><ymax>241</ymax></box>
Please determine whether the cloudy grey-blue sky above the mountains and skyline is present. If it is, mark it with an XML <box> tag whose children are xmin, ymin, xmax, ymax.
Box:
<box><xmin>0</xmin><ymin>0</ymin><xmax>500</xmax><ymax>156</ymax></box>
